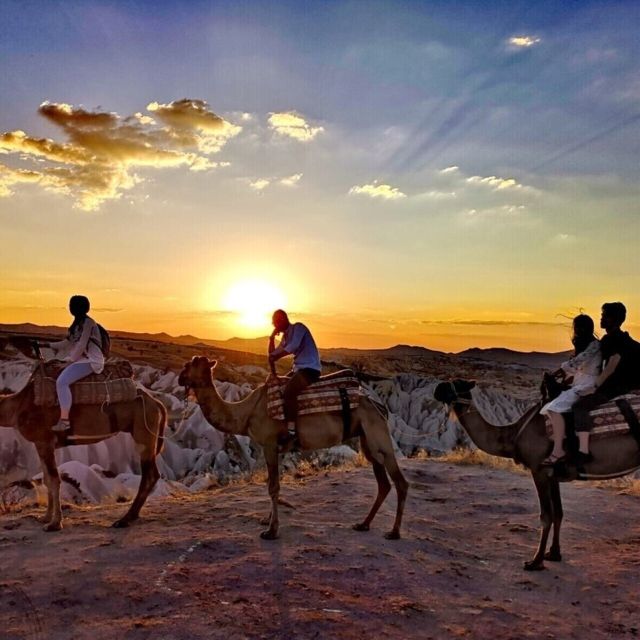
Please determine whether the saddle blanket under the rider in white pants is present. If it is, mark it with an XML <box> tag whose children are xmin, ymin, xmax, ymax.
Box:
<box><xmin>31</xmin><ymin>359</ymin><xmax>137</xmax><ymax>407</ymax></box>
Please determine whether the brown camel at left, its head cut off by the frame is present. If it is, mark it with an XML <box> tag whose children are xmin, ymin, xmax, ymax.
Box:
<box><xmin>0</xmin><ymin>352</ymin><xmax>167</xmax><ymax>531</ymax></box>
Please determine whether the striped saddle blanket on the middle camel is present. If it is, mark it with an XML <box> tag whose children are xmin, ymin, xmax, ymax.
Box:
<box><xmin>267</xmin><ymin>372</ymin><xmax>360</xmax><ymax>420</ymax></box>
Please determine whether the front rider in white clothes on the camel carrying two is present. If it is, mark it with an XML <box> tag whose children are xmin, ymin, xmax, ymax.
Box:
<box><xmin>540</xmin><ymin>313</ymin><xmax>602</xmax><ymax>466</ymax></box>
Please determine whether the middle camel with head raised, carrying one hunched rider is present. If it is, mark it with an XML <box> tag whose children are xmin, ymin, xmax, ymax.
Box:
<box><xmin>178</xmin><ymin>356</ymin><xmax>408</xmax><ymax>540</ymax></box>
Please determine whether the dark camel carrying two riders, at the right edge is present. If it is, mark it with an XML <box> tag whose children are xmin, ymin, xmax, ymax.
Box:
<box><xmin>434</xmin><ymin>380</ymin><xmax>640</xmax><ymax>571</ymax></box>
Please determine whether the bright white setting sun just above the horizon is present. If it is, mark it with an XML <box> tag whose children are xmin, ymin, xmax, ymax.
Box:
<box><xmin>222</xmin><ymin>280</ymin><xmax>286</xmax><ymax>330</ymax></box>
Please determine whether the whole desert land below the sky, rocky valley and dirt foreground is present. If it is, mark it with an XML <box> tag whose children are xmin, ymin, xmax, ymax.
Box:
<box><xmin>0</xmin><ymin>328</ymin><xmax>640</xmax><ymax>640</ymax></box>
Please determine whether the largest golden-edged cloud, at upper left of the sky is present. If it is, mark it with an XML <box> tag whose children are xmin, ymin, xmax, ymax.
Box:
<box><xmin>0</xmin><ymin>99</ymin><xmax>242</xmax><ymax>211</ymax></box>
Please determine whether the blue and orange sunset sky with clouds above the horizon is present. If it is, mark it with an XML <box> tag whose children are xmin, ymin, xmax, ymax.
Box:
<box><xmin>0</xmin><ymin>0</ymin><xmax>640</xmax><ymax>351</ymax></box>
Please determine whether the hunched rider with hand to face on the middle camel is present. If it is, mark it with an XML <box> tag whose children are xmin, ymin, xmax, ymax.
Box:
<box><xmin>269</xmin><ymin>309</ymin><xmax>322</xmax><ymax>439</ymax></box>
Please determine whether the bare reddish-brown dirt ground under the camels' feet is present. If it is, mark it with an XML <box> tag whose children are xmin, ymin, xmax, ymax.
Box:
<box><xmin>0</xmin><ymin>460</ymin><xmax>640</xmax><ymax>640</ymax></box>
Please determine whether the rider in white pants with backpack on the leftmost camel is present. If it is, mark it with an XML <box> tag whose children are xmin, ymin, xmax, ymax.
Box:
<box><xmin>42</xmin><ymin>296</ymin><xmax>104</xmax><ymax>431</ymax></box>
